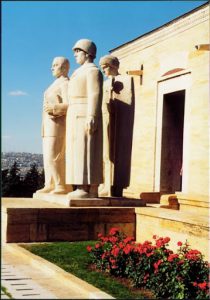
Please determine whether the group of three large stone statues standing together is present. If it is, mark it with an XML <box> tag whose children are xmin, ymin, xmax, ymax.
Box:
<box><xmin>37</xmin><ymin>39</ymin><xmax>134</xmax><ymax>199</ymax></box>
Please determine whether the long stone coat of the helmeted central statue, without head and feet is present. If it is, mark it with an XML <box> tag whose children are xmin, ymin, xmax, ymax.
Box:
<box><xmin>66</xmin><ymin>63</ymin><xmax>103</xmax><ymax>185</ymax></box>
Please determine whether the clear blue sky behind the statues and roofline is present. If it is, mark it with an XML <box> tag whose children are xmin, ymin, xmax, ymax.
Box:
<box><xmin>1</xmin><ymin>1</ymin><xmax>206</xmax><ymax>153</ymax></box>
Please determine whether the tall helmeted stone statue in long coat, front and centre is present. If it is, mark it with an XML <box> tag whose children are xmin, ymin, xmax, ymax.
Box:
<box><xmin>66</xmin><ymin>39</ymin><xmax>103</xmax><ymax>198</ymax></box>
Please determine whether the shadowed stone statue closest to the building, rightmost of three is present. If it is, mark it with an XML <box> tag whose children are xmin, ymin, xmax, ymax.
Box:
<box><xmin>99</xmin><ymin>55</ymin><xmax>134</xmax><ymax>197</ymax></box>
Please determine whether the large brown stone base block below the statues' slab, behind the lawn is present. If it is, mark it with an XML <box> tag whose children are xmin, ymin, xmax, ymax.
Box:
<box><xmin>2</xmin><ymin>198</ymin><xmax>136</xmax><ymax>243</ymax></box>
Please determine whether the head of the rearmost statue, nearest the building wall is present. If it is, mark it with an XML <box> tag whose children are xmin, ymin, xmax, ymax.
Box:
<box><xmin>99</xmin><ymin>55</ymin><xmax>120</xmax><ymax>77</ymax></box>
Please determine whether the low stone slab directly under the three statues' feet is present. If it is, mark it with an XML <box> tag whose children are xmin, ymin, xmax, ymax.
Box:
<box><xmin>33</xmin><ymin>193</ymin><xmax>146</xmax><ymax>207</ymax></box>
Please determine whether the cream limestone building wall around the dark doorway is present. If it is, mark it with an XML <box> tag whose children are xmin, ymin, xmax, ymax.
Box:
<box><xmin>111</xmin><ymin>5</ymin><xmax>209</xmax><ymax>199</ymax></box>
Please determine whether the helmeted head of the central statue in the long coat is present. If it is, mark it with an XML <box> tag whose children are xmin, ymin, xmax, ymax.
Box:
<box><xmin>72</xmin><ymin>39</ymin><xmax>97</xmax><ymax>64</ymax></box>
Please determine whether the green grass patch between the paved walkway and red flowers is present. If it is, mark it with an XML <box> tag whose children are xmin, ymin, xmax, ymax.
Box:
<box><xmin>21</xmin><ymin>241</ymin><xmax>151</xmax><ymax>299</ymax></box>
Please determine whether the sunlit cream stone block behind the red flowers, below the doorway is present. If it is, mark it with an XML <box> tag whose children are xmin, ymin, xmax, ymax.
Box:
<box><xmin>135</xmin><ymin>207</ymin><xmax>210</xmax><ymax>261</ymax></box>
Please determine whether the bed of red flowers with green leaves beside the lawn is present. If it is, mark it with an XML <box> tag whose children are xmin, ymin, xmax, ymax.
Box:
<box><xmin>87</xmin><ymin>228</ymin><xmax>209</xmax><ymax>299</ymax></box>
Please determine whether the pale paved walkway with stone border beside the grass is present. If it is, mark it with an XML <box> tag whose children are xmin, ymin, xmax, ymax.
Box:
<box><xmin>1</xmin><ymin>244</ymin><xmax>113</xmax><ymax>299</ymax></box>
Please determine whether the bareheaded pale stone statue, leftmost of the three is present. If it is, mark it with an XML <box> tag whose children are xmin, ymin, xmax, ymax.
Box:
<box><xmin>37</xmin><ymin>57</ymin><xmax>70</xmax><ymax>194</ymax></box>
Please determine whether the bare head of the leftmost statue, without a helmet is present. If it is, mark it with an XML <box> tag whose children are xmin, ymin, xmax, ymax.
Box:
<box><xmin>51</xmin><ymin>56</ymin><xmax>70</xmax><ymax>78</ymax></box>
